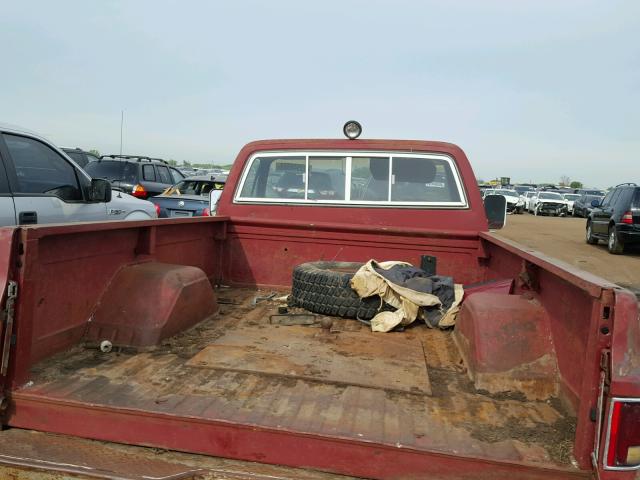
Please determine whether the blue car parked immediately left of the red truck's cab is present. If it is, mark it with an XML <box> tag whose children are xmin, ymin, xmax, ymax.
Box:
<box><xmin>149</xmin><ymin>175</ymin><xmax>227</xmax><ymax>218</ymax></box>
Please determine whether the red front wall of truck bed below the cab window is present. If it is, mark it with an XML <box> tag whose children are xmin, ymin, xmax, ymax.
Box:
<box><xmin>224</xmin><ymin>219</ymin><xmax>481</xmax><ymax>286</ymax></box>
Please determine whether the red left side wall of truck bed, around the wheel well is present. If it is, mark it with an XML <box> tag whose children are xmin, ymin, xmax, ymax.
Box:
<box><xmin>11</xmin><ymin>218</ymin><xmax>226</xmax><ymax>385</ymax></box>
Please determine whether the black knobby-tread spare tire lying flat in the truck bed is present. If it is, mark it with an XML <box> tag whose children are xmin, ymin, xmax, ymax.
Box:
<box><xmin>289</xmin><ymin>262</ymin><xmax>386</xmax><ymax>320</ymax></box>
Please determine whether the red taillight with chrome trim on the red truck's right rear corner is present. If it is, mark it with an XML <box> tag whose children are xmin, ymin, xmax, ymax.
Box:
<box><xmin>604</xmin><ymin>398</ymin><xmax>640</xmax><ymax>470</ymax></box>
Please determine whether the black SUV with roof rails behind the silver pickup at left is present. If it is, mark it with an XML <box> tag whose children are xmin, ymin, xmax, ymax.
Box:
<box><xmin>84</xmin><ymin>155</ymin><xmax>185</xmax><ymax>199</ymax></box>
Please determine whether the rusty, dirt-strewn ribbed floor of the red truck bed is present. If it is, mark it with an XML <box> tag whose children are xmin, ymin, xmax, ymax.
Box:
<box><xmin>14</xmin><ymin>289</ymin><xmax>575</xmax><ymax>469</ymax></box>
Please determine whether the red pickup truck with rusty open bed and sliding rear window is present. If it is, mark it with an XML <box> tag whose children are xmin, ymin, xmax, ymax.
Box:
<box><xmin>0</xmin><ymin>128</ymin><xmax>640</xmax><ymax>479</ymax></box>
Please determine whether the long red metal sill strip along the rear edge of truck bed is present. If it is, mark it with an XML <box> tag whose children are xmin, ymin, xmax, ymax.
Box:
<box><xmin>10</xmin><ymin>393</ymin><xmax>591</xmax><ymax>480</ymax></box>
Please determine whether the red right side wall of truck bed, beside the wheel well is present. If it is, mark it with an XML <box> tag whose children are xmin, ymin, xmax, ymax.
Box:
<box><xmin>482</xmin><ymin>234</ymin><xmax>615</xmax><ymax>468</ymax></box>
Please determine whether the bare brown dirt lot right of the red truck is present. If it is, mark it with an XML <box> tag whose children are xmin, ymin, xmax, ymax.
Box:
<box><xmin>494</xmin><ymin>213</ymin><xmax>640</xmax><ymax>295</ymax></box>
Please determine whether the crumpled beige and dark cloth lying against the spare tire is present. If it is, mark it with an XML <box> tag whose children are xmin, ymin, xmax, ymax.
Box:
<box><xmin>351</xmin><ymin>260</ymin><xmax>464</xmax><ymax>332</ymax></box>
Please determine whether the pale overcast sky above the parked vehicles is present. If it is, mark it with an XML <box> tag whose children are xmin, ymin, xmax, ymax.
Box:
<box><xmin>0</xmin><ymin>0</ymin><xmax>640</xmax><ymax>187</ymax></box>
